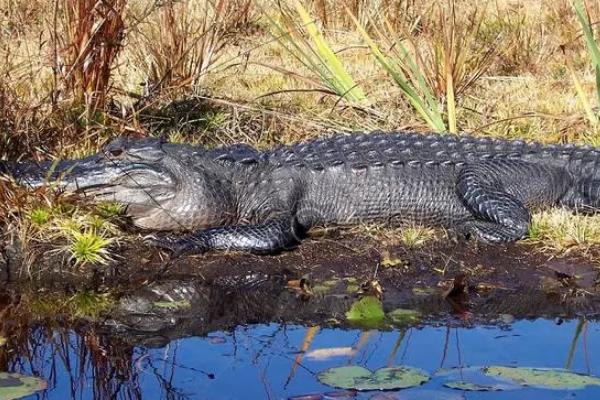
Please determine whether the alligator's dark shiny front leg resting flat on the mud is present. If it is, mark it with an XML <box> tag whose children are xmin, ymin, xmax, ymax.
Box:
<box><xmin>147</xmin><ymin>217</ymin><xmax>304</xmax><ymax>257</ymax></box>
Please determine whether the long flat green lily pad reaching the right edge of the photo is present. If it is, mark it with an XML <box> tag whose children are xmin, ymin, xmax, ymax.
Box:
<box><xmin>484</xmin><ymin>366</ymin><xmax>600</xmax><ymax>390</ymax></box>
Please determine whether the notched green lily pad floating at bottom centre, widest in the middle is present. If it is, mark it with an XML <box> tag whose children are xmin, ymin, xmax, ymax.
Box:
<box><xmin>317</xmin><ymin>366</ymin><xmax>430</xmax><ymax>391</ymax></box>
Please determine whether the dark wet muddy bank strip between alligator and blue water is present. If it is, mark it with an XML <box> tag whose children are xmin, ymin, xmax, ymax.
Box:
<box><xmin>3</xmin><ymin>235</ymin><xmax>600</xmax><ymax>343</ymax></box>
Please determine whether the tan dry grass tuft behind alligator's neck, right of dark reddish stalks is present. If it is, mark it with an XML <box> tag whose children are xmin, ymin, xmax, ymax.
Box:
<box><xmin>130</xmin><ymin>0</ymin><xmax>252</xmax><ymax>97</ymax></box>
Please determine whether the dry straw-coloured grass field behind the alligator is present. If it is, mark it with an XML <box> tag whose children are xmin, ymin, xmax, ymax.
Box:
<box><xmin>0</xmin><ymin>0</ymin><xmax>600</xmax><ymax>256</ymax></box>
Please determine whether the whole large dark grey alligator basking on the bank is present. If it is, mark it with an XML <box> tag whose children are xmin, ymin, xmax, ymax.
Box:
<box><xmin>5</xmin><ymin>132</ymin><xmax>600</xmax><ymax>255</ymax></box>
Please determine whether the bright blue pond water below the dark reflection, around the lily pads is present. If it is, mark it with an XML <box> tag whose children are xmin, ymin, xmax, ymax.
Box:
<box><xmin>0</xmin><ymin>319</ymin><xmax>600</xmax><ymax>400</ymax></box>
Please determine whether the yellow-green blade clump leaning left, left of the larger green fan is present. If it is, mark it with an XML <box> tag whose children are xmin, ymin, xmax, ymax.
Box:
<box><xmin>267</xmin><ymin>1</ymin><xmax>367</xmax><ymax>103</ymax></box>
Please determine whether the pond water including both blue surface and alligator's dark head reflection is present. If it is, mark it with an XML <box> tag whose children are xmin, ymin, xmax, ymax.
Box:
<box><xmin>0</xmin><ymin>277</ymin><xmax>600</xmax><ymax>400</ymax></box>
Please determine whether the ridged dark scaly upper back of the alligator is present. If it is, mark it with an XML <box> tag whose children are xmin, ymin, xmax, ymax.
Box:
<box><xmin>265</xmin><ymin>131</ymin><xmax>600</xmax><ymax>174</ymax></box>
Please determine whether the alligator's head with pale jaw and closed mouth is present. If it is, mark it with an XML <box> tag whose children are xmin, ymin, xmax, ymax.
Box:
<box><xmin>6</xmin><ymin>138</ymin><xmax>231</xmax><ymax>230</ymax></box>
